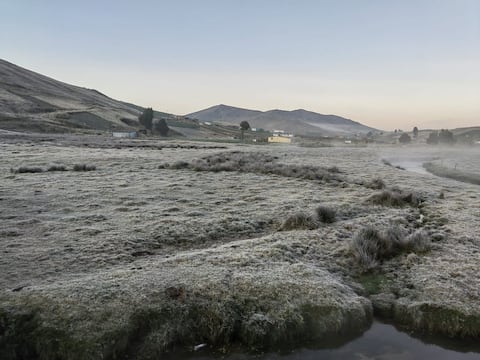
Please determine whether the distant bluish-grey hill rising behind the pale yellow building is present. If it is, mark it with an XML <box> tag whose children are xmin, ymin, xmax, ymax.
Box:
<box><xmin>186</xmin><ymin>105</ymin><xmax>378</xmax><ymax>136</ymax></box>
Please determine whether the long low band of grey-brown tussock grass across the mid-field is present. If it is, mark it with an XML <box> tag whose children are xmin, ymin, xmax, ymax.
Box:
<box><xmin>169</xmin><ymin>151</ymin><xmax>340</xmax><ymax>182</ymax></box>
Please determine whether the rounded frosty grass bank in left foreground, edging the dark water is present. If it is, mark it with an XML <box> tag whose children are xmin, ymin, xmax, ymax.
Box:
<box><xmin>0</xmin><ymin>254</ymin><xmax>372</xmax><ymax>360</ymax></box>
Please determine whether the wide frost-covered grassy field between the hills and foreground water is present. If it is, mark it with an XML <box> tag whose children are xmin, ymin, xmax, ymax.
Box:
<box><xmin>0</xmin><ymin>137</ymin><xmax>480</xmax><ymax>358</ymax></box>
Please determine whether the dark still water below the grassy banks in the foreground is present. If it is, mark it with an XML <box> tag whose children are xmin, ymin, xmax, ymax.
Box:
<box><xmin>171</xmin><ymin>321</ymin><xmax>480</xmax><ymax>360</ymax></box>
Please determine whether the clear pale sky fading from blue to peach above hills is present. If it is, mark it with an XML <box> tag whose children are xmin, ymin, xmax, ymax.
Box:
<box><xmin>0</xmin><ymin>0</ymin><xmax>480</xmax><ymax>130</ymax></box>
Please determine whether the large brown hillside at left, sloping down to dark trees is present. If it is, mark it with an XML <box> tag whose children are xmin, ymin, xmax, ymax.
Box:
<box><xmin>0</xmin><ymin>59</ymin><xmax>142</xmax><ymax>132</ymax></box>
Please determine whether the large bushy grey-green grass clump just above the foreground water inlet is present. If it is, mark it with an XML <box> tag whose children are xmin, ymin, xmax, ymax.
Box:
<box><xmin>351</xmin><ymin>225</ymin><xmax>431</xmax><ymax>271</ymax></box>
